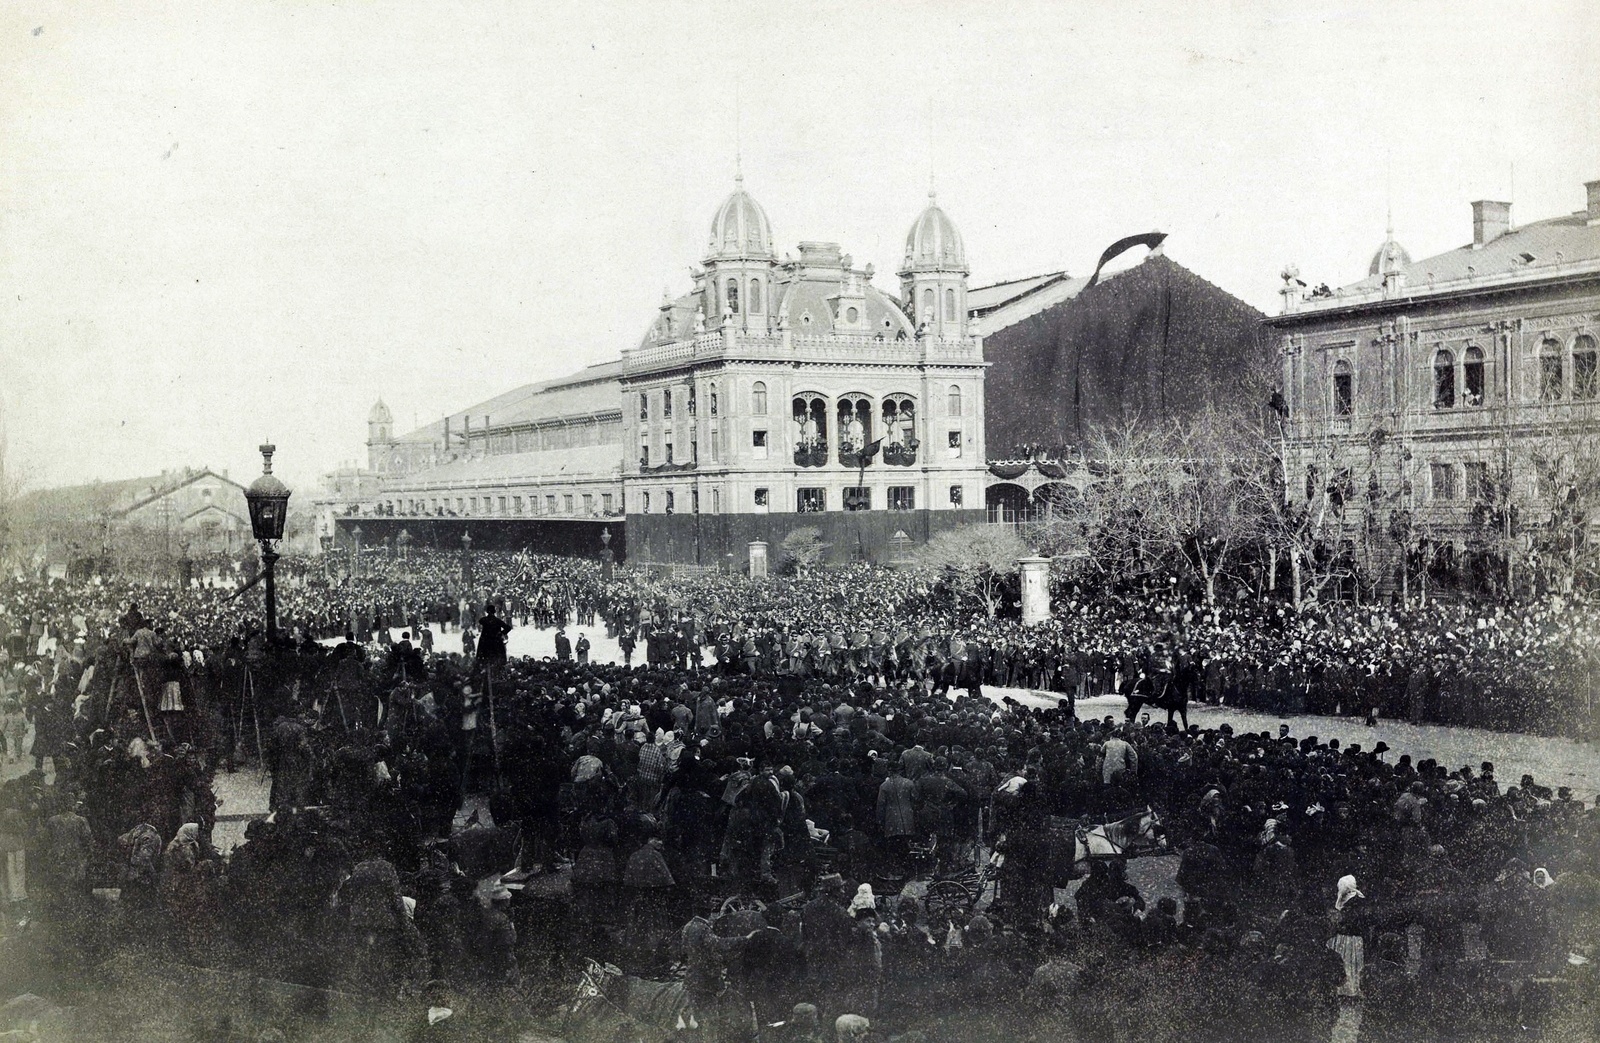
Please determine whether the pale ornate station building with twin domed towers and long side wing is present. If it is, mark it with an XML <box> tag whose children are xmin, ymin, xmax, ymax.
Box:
<box><xmin>320</xmin><ymin>178</ymin><xmax>987</xmax><ymax>565</ymax></box>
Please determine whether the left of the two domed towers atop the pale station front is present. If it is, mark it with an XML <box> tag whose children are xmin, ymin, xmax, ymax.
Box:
<box><xmin>706</xmin><ymin>174</ymin><xmax>778</xmax><ymax>333</ymax></box>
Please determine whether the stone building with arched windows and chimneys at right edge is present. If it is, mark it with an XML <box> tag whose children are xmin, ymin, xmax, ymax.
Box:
<box><xmin>1267</xmin><ymin>181</ymin><xmax>1600</xmax><ymax>584</ymax></box>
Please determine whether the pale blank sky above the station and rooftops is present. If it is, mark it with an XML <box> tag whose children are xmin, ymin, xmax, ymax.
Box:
<box><xmin>0</xmin><ymin>0</ymin><xmax>1600</xmax><ymax>491</ymax></box>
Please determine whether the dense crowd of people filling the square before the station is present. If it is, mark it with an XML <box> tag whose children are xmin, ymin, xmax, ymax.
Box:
<box><xmin>0</xmin><ymin>552</ymin><xmax>1600</xmax><ymax>1040</ymax></box>
